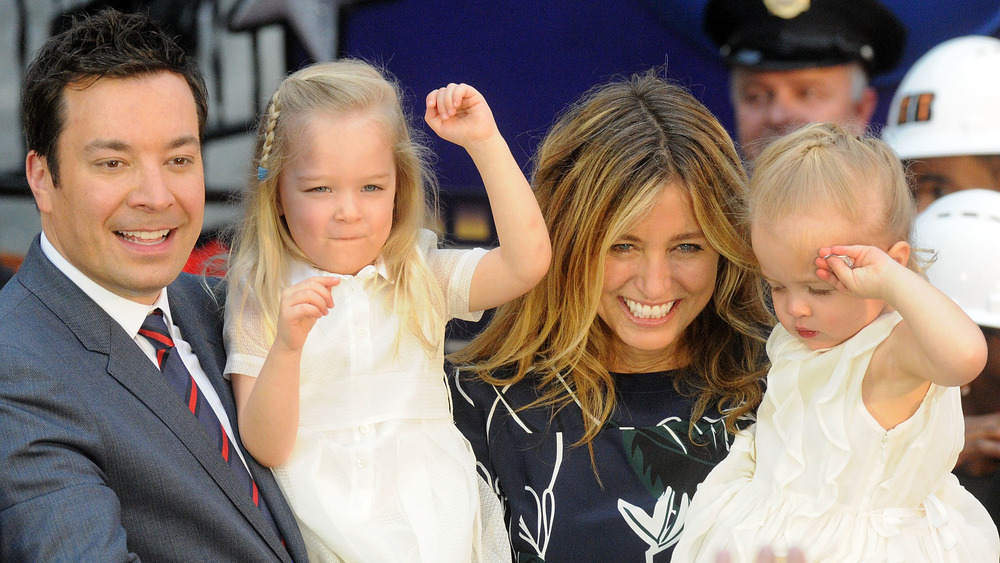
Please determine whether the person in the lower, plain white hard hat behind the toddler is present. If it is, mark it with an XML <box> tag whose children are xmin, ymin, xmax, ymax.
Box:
<box><xmin>914</xmin><ymin>191</ymin><xmax>1000</xmax><ymax>523</ymax></box>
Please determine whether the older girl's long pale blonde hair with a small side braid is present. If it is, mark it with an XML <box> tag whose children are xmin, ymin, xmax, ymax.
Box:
<box><xmin>227</xmin><ymin>59</ymin><xmax>444</xmax><ymax>350</ymax></box>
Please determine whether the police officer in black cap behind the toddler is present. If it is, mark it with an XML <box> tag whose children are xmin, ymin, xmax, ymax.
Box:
<box><xmin>704</xmin><ymin>0</ymin><xmax>906</xmax><ymax>161</ymax></box>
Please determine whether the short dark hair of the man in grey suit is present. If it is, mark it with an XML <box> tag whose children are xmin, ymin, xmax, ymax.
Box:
<box><xmin>21</xmin><ymin>9</ymin><xmax>208</xmax><ymax>182</ymax></box>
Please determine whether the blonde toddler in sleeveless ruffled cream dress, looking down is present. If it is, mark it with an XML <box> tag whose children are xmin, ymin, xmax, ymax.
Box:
<box><xmin>673</xmin><ymin>124</ymin><xmax>1000</xmax><ymax>563</ymax></box>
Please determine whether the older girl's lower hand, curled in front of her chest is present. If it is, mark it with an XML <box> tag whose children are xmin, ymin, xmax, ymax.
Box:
<box><xmin>274</xmin><ymin>276</ymin><xmax>340</xmax><ymax>350</ymax></box>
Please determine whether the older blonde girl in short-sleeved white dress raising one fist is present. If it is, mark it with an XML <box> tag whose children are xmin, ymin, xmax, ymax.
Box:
<box><xmin>226</xmin><ymin>60</ymin><xmax>551</xmax><ymax>562</ymax></box>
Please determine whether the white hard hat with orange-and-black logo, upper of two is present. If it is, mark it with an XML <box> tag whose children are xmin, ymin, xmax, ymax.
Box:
<box><xmin>882</xmin><ymin>35</ymin><xmax>1000</xmax><ymax>159</ymax></box>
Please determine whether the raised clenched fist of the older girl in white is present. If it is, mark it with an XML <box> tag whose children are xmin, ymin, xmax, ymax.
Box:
<box><xmin>424</xmin><ymin>83</ymin><xmax>499</xmax><ymax>149</ymax></box>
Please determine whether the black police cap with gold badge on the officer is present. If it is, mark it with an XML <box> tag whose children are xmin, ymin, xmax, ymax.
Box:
<box><xmin>705</xmin><ymin>0</ymin><xmax>906</xmax><ymax>75</ymax></box>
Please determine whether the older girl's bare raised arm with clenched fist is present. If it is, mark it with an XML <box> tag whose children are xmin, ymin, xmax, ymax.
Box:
<box><xmin>424</xmin><ymin>84</ymin><xmax>552</xmax><ymax>311</ymax></box>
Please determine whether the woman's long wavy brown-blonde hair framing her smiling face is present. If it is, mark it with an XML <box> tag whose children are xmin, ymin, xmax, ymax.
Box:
<box><xmin>452</xmin><ymin>71</ymin><xmax>773</xmax><ymax>447</ymax></box>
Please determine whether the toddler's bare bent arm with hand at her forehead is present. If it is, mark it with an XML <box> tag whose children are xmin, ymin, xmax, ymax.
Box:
<box><xmin>816</xmin><ymin>242</ymin><xmax>987</xmax><ymax>387</ymax></box>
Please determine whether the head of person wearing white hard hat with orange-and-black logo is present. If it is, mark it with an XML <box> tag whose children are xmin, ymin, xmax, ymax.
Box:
<box><xmin>882</xmin><ymin>35</ymin><xmax>1000</xmax><ymax>210</ymax></box>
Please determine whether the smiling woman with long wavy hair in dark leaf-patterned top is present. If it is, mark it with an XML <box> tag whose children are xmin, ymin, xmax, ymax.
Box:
<box><xmin>449</xmin><ymin>71</ymin><xmax>772</xmax><ymax>561</ymax></box>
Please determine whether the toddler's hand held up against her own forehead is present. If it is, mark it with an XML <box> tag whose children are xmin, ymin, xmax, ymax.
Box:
<box><xmin>815</xmin><ymin>245</ymin><xmax>899</xmax><ymax>299</ymax></box>
